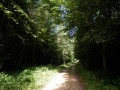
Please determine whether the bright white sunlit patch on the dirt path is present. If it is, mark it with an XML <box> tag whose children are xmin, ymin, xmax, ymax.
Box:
<box><xmin>41</xmin><ymin>72</ymin><xmax>68</xmax><ymax>90</ymax></box>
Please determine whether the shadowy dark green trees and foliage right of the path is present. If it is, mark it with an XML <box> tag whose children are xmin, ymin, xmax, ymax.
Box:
<box><xmin>66</xmin><ymin>0</ymin><xmax>120</xmax><ymax>72</ymax></box>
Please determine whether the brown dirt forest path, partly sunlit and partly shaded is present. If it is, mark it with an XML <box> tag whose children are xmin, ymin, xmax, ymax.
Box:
<box><xmin>42</xmin><ymin>66</ymin><xmax>85</xmax><ymax>90</ymax></box>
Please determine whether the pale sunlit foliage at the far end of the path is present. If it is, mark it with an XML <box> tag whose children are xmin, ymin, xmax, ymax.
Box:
<box><xmin>56</xmin><ymin>24</ymin><xmax>75</xmax><ymax>64</ymax></box>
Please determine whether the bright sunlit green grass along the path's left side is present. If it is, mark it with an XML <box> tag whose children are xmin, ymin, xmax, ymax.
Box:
<box><xmin>0</xmin><ymin>66</ymin><xmax>57</xmax><ymax>90</ymax></box>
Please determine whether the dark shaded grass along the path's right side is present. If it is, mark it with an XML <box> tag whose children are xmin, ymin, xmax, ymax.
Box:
<box><xmin>75</xmin><ymin>64</ymin><xmax>120</xmax><ymax>90</ymax></box>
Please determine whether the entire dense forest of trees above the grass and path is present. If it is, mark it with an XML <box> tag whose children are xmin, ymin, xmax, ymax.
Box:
<box><xmin>0</xmin><ymin>0</ymin><xmax>120</xmax><ymax>74</ymax></box>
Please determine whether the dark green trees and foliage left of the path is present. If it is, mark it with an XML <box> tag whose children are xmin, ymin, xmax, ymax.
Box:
<box><xmin>0</xmin><ymin>0</ymin><xmax>63</xmax><ymax>70</ymax></box>
